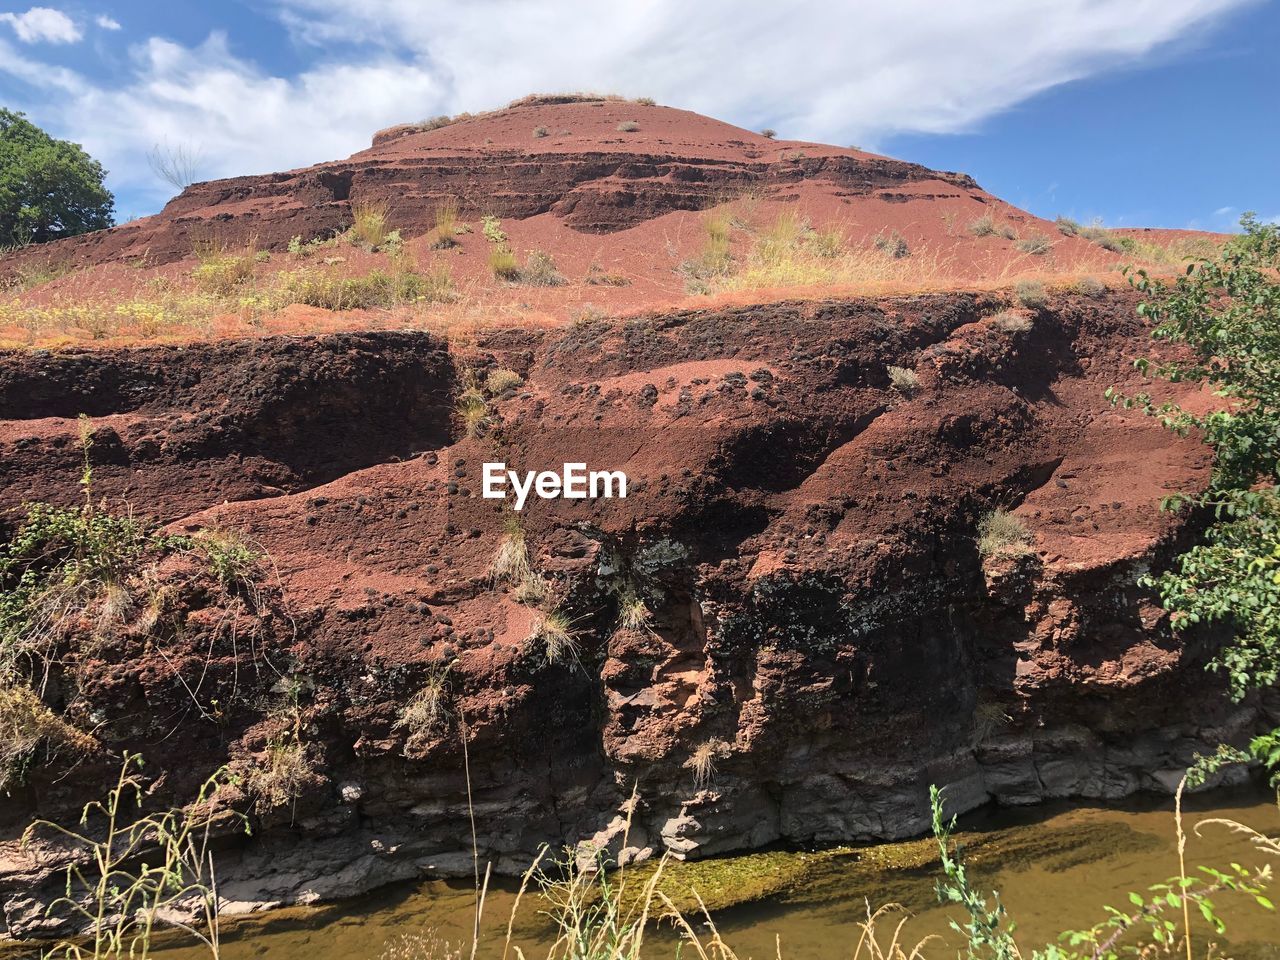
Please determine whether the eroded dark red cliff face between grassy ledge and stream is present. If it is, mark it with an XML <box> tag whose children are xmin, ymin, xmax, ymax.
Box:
<box><xmin>0</xmin><ymin>294</ymin><xmax>1258</xmax><ymax>933</ymax></box>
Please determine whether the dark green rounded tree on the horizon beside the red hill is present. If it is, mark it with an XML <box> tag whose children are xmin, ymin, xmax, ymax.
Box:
<box><xmin>0</xmin><ymin>109</ymin><xmax>115</xmax><ymax>246</ymax></box>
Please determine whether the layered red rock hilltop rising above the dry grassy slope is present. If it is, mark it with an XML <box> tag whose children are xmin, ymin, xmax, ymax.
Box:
<box><xmin>0</xmin><ymin>99</ymin><xmax>991</xmax><ymax>279</ymax></box>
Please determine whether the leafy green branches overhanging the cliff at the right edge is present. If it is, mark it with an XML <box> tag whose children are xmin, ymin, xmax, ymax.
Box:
<box><xmin>1108</xmin><ymin>215</ymin><xmax>1280</xmax><ymax>768</ymax></box>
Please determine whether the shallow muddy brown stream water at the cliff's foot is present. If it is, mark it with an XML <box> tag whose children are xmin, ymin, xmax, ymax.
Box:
<box><xmin>152</xmin><ymin>792</ymin><xmax>1280</xmax><ymax>960</ymax></box>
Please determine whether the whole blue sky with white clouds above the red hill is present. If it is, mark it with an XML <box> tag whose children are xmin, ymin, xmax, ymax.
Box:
<box><xmin>0</xmin><ymin>0</ymin><xmax>1280</xmax><ymax>229</ymax></box>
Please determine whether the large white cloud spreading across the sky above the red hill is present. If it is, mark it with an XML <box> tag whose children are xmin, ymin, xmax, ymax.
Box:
<box><xmin>0</xmin><ymin>0</ymin><xmax>1251</xmax><ymax>212</ymax></box>
